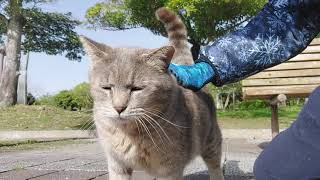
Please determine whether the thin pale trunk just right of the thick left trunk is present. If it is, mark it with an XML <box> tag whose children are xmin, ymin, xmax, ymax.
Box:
<box><xmin>17</xmin><ymin>52</ymin><xmax>29</xmax><ymax>105</ymax></box>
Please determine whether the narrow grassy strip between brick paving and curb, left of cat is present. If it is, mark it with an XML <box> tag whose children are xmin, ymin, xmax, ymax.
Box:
<box><xmin>0</xmin><ymin>140</ymin><xmax>93</xmax><ymax>153</ymax></box>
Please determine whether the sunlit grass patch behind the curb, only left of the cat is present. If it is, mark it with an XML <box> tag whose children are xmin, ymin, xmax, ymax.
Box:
<box><xmin>0</xmin><ymin>105</ymin><xmax>92</xmax><ymax>131</ymax></box>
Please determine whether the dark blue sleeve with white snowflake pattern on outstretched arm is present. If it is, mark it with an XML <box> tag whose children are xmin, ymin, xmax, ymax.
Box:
<box><xmin>198</xmin><ymin>0</ymin><xmax>320</xmax><ymax>86</ymax></box>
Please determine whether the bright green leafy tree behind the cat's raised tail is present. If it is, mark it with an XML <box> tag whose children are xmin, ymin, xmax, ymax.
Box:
<box><xmin>86</xmin><ymin>0</ymin><xmax>267</xmax><ymax>59</ymax></box>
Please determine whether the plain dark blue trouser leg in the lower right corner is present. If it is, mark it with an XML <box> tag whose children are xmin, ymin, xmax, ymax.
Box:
<box><xmin>254</xmin><ymin>87</ymin><xmax>320</xmax><ymax>180</ymax></box>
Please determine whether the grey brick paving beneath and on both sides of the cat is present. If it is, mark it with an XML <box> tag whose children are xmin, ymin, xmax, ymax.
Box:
<box><xmin>0</xmin><ymin>139</ymin><xmax>265</xmax><ymax>180</ymax></box>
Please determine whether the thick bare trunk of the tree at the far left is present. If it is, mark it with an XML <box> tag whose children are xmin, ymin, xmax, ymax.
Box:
<box><xmin>0</xmin><ymin>0</ymin><xmax>23</xmax><ymax>107</ymax></box>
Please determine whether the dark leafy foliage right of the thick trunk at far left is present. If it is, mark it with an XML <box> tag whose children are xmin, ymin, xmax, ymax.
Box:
<box><xmin>22</xmin><ymin>9</ymin><xmax>83</xmax><ymax>60</ymax></box>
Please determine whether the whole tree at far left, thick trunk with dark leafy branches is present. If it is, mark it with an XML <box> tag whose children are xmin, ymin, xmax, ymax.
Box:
<box><xmin>0</xmin><ymin>0</ymin><xmax>84</xmax><ymax>107</ymax></box>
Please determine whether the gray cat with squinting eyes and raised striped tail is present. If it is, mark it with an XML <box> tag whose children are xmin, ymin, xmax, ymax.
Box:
<box><xmin>81</xmin><ymin>8</ymin><xmax>224</xmax><ymax>180</ymax></box>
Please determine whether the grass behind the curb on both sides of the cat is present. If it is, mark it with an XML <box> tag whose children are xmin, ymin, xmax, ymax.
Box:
<box><xmin>0</xmin><ymin>105</ymin><xmax>302</xmax><ymax>131</ymax></box>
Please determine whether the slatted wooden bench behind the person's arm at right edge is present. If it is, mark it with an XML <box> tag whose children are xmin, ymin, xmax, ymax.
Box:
<box><xmin>242</xmin><ymin>38</ymin><xmax>320</xmax><ymax>138</ymax></box>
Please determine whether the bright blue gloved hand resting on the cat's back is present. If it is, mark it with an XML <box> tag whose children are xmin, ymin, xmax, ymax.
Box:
<box><xmin>169</xmin><ymin>62</ymin><xmax>215</xmax><ymax>91</ymax></box>
